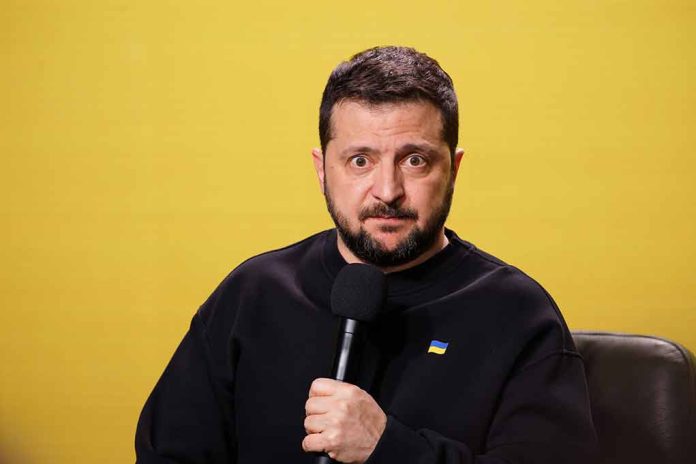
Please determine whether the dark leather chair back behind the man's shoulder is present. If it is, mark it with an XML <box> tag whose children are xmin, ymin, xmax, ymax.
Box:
<box><xmin>573</xmin><ymin>332</ymin><xmax>696</xmax><ymax>464</ymax></box>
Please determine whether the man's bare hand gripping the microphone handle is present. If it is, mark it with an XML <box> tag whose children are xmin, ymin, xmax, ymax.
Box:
<box><xmin>302</xmin><ymin>379</ymin><xmax>387</xmax><ymax>464</ymax></box>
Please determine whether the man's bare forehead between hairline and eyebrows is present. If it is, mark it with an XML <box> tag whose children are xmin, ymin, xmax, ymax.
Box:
<box><xmin>327</xmin><ymin>100</ymin><xmax>447</xmax><ymax>149</ymax></box>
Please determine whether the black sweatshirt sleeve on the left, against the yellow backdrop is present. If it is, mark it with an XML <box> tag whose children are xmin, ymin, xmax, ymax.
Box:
<box><xmin>135</xmin><ymin>314</ymin><xmax>235</xmax><ymax>464</ymax></box>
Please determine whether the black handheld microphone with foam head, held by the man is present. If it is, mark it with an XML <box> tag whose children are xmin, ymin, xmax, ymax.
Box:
<box><xmin>315</xmin><ymin>264</ymin><xmax>387</xmax><ymax>464</ymax></box>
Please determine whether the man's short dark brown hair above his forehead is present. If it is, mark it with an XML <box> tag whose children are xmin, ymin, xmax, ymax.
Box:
<box><xmin>319</xmin><ymin>47</ymin><xmax>459</xmax><ymax>156</ymax></box>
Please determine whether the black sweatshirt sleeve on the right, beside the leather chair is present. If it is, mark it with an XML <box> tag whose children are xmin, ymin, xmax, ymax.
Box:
<box><xmin>366</xmin><ymin>352</ymin><xmax>597</xmax><ymax>464</ymax></box>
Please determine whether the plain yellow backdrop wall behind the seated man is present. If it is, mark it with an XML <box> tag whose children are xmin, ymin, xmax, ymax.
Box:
<box><xmin>0</xmin><ymin>0</ymin><xmax>696</xmax><ymax>463</ymax></box>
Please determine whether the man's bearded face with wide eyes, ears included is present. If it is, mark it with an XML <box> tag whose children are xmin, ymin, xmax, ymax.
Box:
<box><xmin>313</xmin><ymin>100</ymin><xmax>462</xmax><ymax>267</ymax></box>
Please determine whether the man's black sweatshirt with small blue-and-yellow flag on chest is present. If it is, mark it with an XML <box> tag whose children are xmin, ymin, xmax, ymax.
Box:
<box><xmin>136</xmin><ymin>230</ymin><xmax>596</xmax><ymax>464</ymax></box>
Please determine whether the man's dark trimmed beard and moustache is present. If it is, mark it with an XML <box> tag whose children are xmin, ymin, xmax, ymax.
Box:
<box><xmin>324</xmin><ymin>180</ymin><xmax>454</xmax><ymax>267</ymax></box>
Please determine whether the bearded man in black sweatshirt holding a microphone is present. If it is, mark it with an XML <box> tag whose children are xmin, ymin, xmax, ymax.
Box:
<box><xmin>136</xmin><ymin>47</ymin><xmax>596</xmax><ymax>464</ymax></box>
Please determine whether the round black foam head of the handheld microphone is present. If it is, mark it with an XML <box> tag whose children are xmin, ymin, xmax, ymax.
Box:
<box><xmin>331</xmin><ymin>263</ymin><xmax>387</xmax><ymax>322</ymax></box>
